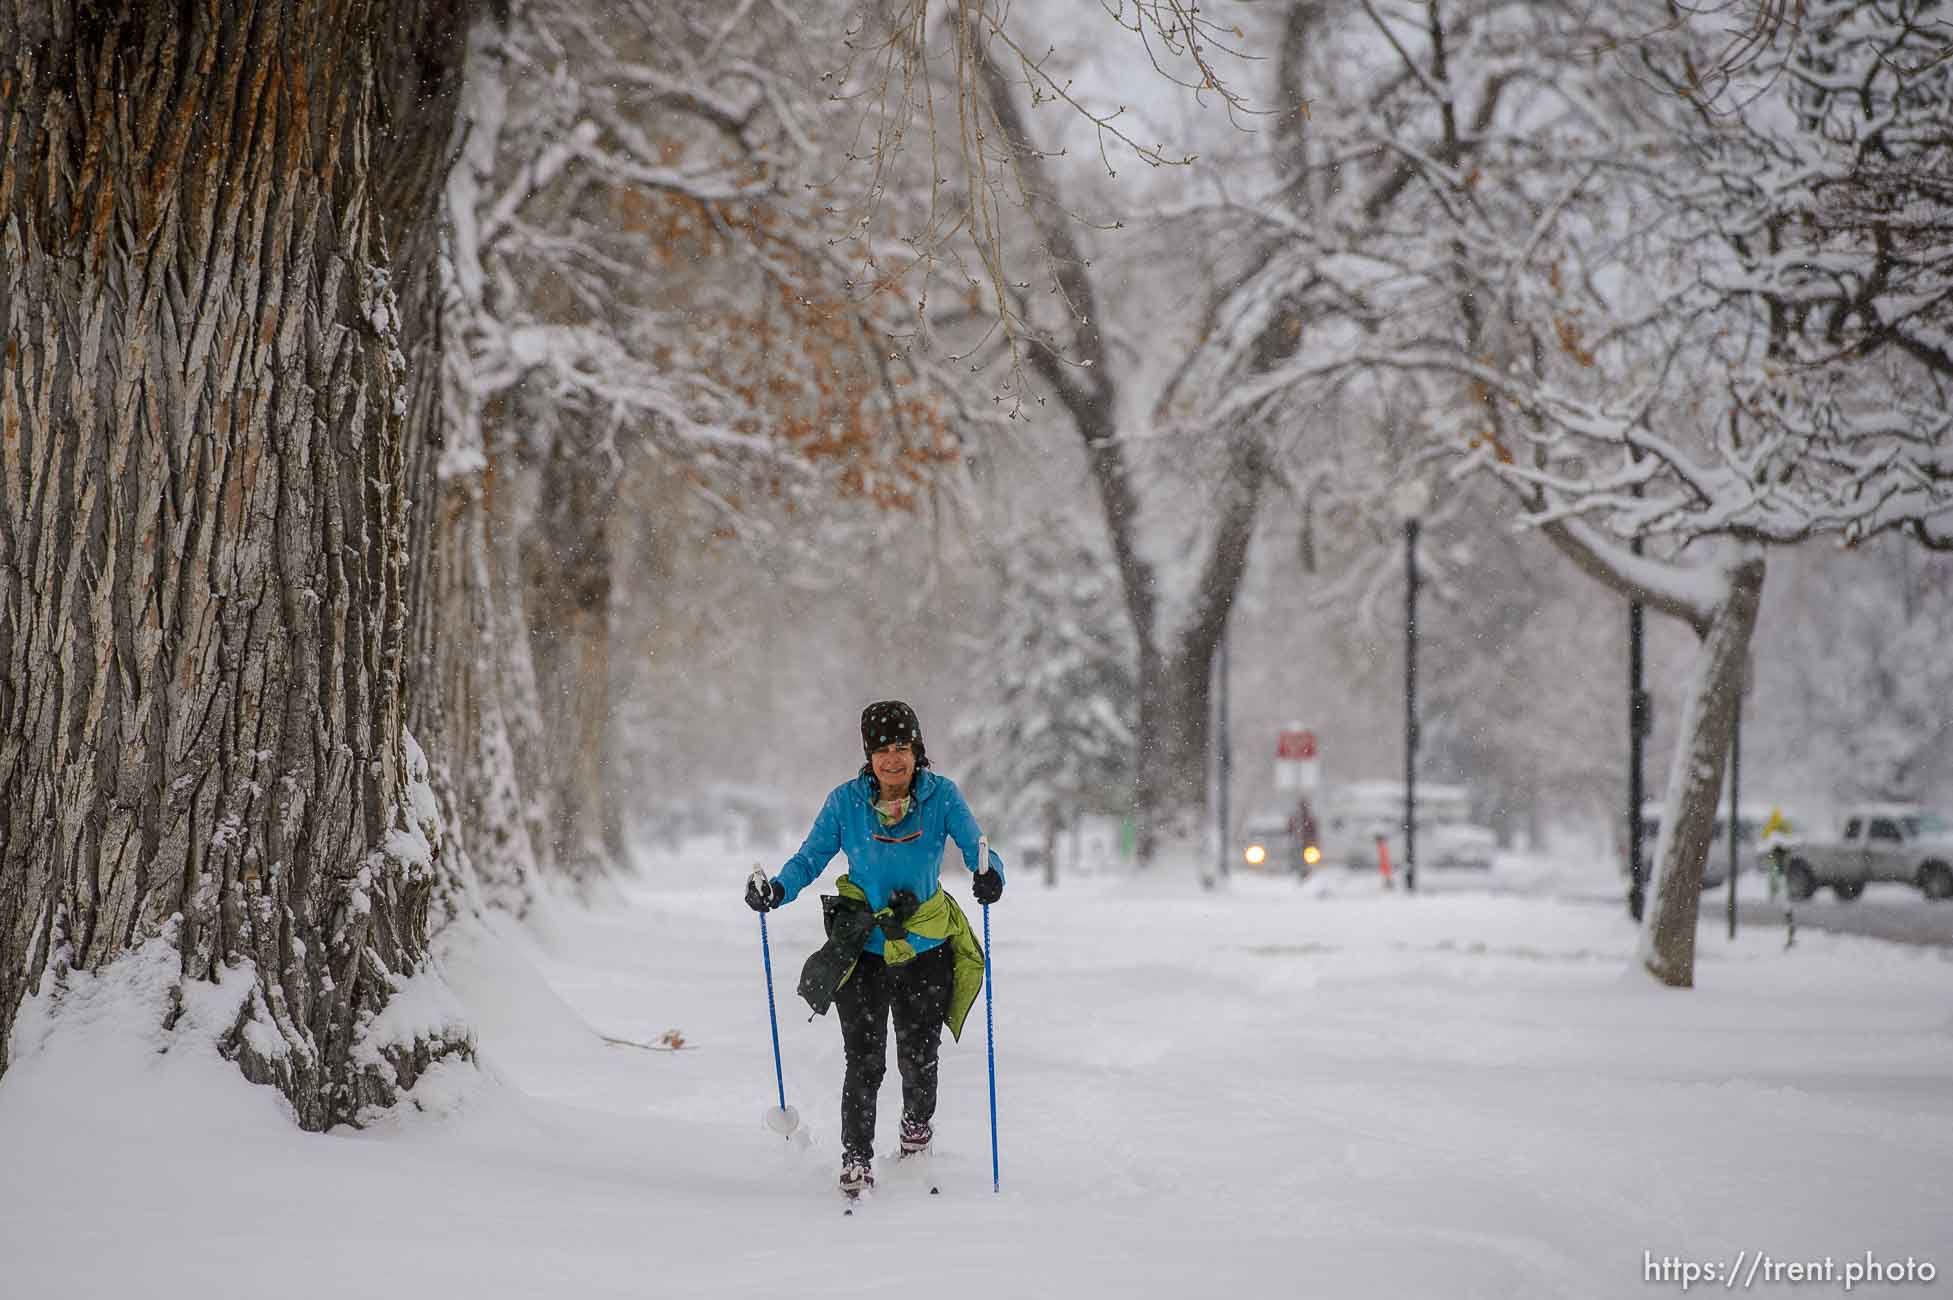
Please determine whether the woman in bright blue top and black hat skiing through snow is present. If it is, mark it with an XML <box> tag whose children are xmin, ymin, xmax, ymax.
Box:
<box><xmin>746</xmin><ymin>701</ymin><xmax>1004</xmax><ymax>1197</ymax></box>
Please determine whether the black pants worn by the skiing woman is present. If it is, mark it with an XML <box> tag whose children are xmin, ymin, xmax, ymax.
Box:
<box><xmin>834</xmin><ymin>943</ymin><xmax>953</xmax><ymax>1163</ymax></box>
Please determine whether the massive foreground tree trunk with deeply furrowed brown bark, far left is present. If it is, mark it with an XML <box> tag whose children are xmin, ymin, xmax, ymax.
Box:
<box><xmin>0</xmin><ymin>0</ymin><xmax>473</xmax><ymax>1130</ymax></box>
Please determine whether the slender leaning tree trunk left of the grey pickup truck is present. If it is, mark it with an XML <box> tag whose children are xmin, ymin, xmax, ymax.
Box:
<box><xmin>1637</xmin><ymin>556</ymin><xmax>1764</xmax><ymax>988</ymax></box>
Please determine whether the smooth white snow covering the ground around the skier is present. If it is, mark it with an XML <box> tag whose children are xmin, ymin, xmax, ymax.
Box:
<box><xmin>0</xmin><ymin>859</ymin><xmax>1953</xmax><ymax>1300</ymax></box>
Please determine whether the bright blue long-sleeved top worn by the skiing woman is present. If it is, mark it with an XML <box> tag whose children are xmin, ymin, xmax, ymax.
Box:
<box><xmin>773</xmin><ymin>767</ymin><xmax>1004</xmax><ymax>956</ymax></box>
